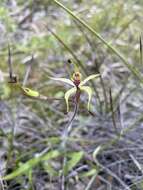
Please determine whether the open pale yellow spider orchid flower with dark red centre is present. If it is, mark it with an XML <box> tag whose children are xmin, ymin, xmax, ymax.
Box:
<box><xmin>49</xmin><ymin>72</ymin><xmax>100</xmax><ymax>113</ymax></box>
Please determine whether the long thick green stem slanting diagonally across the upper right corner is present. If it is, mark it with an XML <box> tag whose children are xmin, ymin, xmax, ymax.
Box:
<box><xmin>53</xmin><ymin>0</ymin><xmax>143</xmax><ymax>83</ymax></box>
